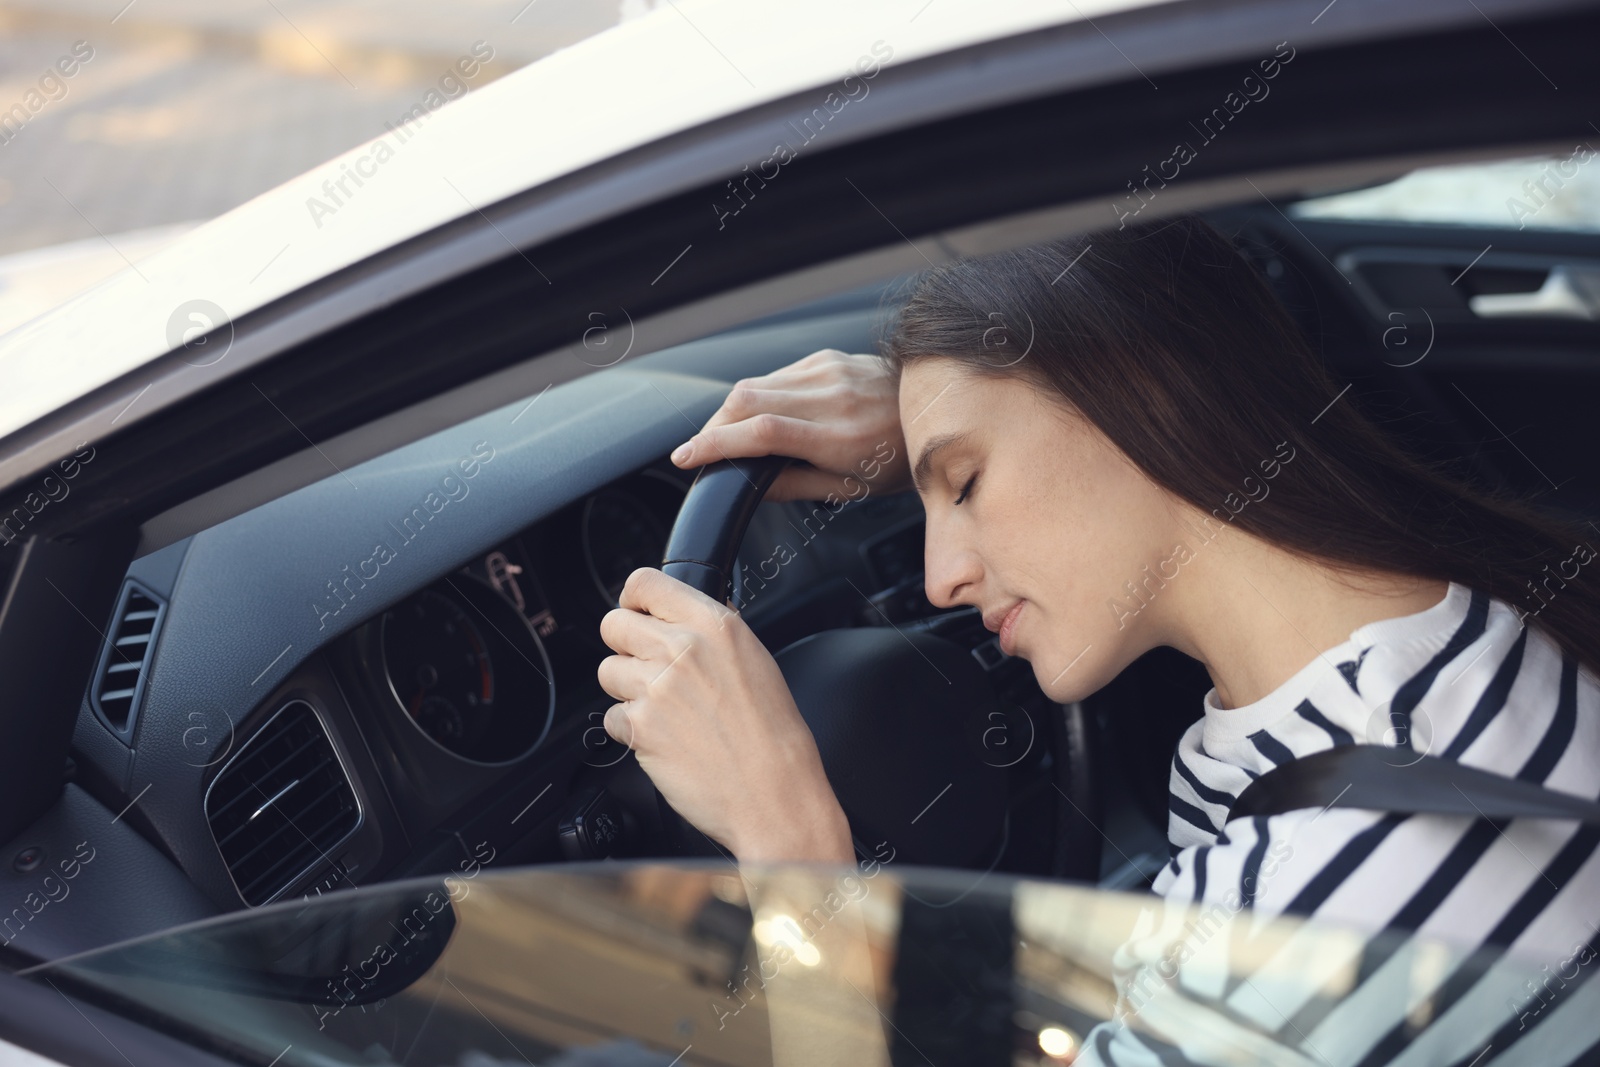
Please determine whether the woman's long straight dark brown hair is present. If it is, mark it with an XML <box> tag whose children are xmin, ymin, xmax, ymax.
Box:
<box><xmin>882</xmin><ymin>218</ymin><xmax>1600</xmax><ymax>672</ymax></box>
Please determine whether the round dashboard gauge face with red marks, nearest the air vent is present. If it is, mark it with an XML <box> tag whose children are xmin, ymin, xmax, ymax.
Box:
<box><xmin>382</xmin><ymin>590</ymin><xmax>494</xmax><ymax>752</ymax></box>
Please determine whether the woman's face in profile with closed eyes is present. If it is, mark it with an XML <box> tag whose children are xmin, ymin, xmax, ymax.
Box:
<box><xmin>899</xmin><ymin>358</ymin><xmax>1194</xmax><ymax>704</ymax></box>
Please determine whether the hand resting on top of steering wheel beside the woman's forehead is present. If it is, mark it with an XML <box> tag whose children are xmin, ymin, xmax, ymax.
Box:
<box><xmin>672</xmin><ymin>349</ymin><xmax>910</xmax><ymax>501</ymax></box>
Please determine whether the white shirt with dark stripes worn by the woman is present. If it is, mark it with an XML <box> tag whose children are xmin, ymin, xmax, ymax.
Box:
<box><xmin>1078</xmin><ymin>582</ymin><xmax>1600</xmax><ymax>1067</ymax></box>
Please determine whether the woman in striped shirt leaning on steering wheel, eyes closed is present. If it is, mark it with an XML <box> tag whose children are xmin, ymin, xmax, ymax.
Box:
<box><xmin>600</xmin><ymin>219</ymin><xmax>1600</xmax><ymax>1062</ymax></box>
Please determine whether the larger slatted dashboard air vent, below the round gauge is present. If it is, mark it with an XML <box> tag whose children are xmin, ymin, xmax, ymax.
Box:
<box><xmin>205</xmin><ymin>701</ymin><xmax>362</xmax><ymax>907</ymax></box>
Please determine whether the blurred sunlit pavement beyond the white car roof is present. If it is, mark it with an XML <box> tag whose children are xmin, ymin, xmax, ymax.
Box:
<box><xmin>0</xmin><ymin>0</ymin><xmax>661</xmax><ymax>333</ymax></box>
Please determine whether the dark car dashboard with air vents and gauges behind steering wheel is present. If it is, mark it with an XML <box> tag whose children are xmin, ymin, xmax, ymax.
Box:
<box><xmin>62</xmin><ymin>302</ymin><xmax>922</xmax><ymax>927</ymax></box>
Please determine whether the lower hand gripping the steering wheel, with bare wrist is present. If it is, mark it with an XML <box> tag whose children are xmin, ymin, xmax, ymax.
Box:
<box><xmin>598</xmin><ymin>568</ymin><xmax>854</xmax><ymax>864</ymax></box>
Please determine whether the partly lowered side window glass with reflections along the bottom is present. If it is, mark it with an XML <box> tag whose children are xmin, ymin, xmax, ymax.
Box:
<box><xmin>15</xmin><ymin>857</ymin><xmax>1561</xmax><ymax>1067</ymax></box>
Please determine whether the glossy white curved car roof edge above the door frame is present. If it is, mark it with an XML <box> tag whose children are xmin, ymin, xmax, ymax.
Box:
<box><xmin>0</xmin><ymin>0</ymin><xmax>1154</xmax><ymax>437</ymax></box>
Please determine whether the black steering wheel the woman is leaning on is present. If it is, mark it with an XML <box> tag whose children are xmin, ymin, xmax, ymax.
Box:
<box><xmin>643</xmin><ymin>456</ymin><xmax>1099</xmax><ymax>877</ymax></box>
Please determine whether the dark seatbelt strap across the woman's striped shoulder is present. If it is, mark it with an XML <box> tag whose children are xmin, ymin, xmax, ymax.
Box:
<box><xmin>1227</xmin><ymin>744</ymin><xmax>1600</xmax><ymax>824</ymax></box>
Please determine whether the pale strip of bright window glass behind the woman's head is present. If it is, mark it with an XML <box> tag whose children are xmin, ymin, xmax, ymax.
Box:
<box><xmin>1290</xmin><ymin>142</ymin><xmax>1600</xmax><ymax>230</ymax></box>
